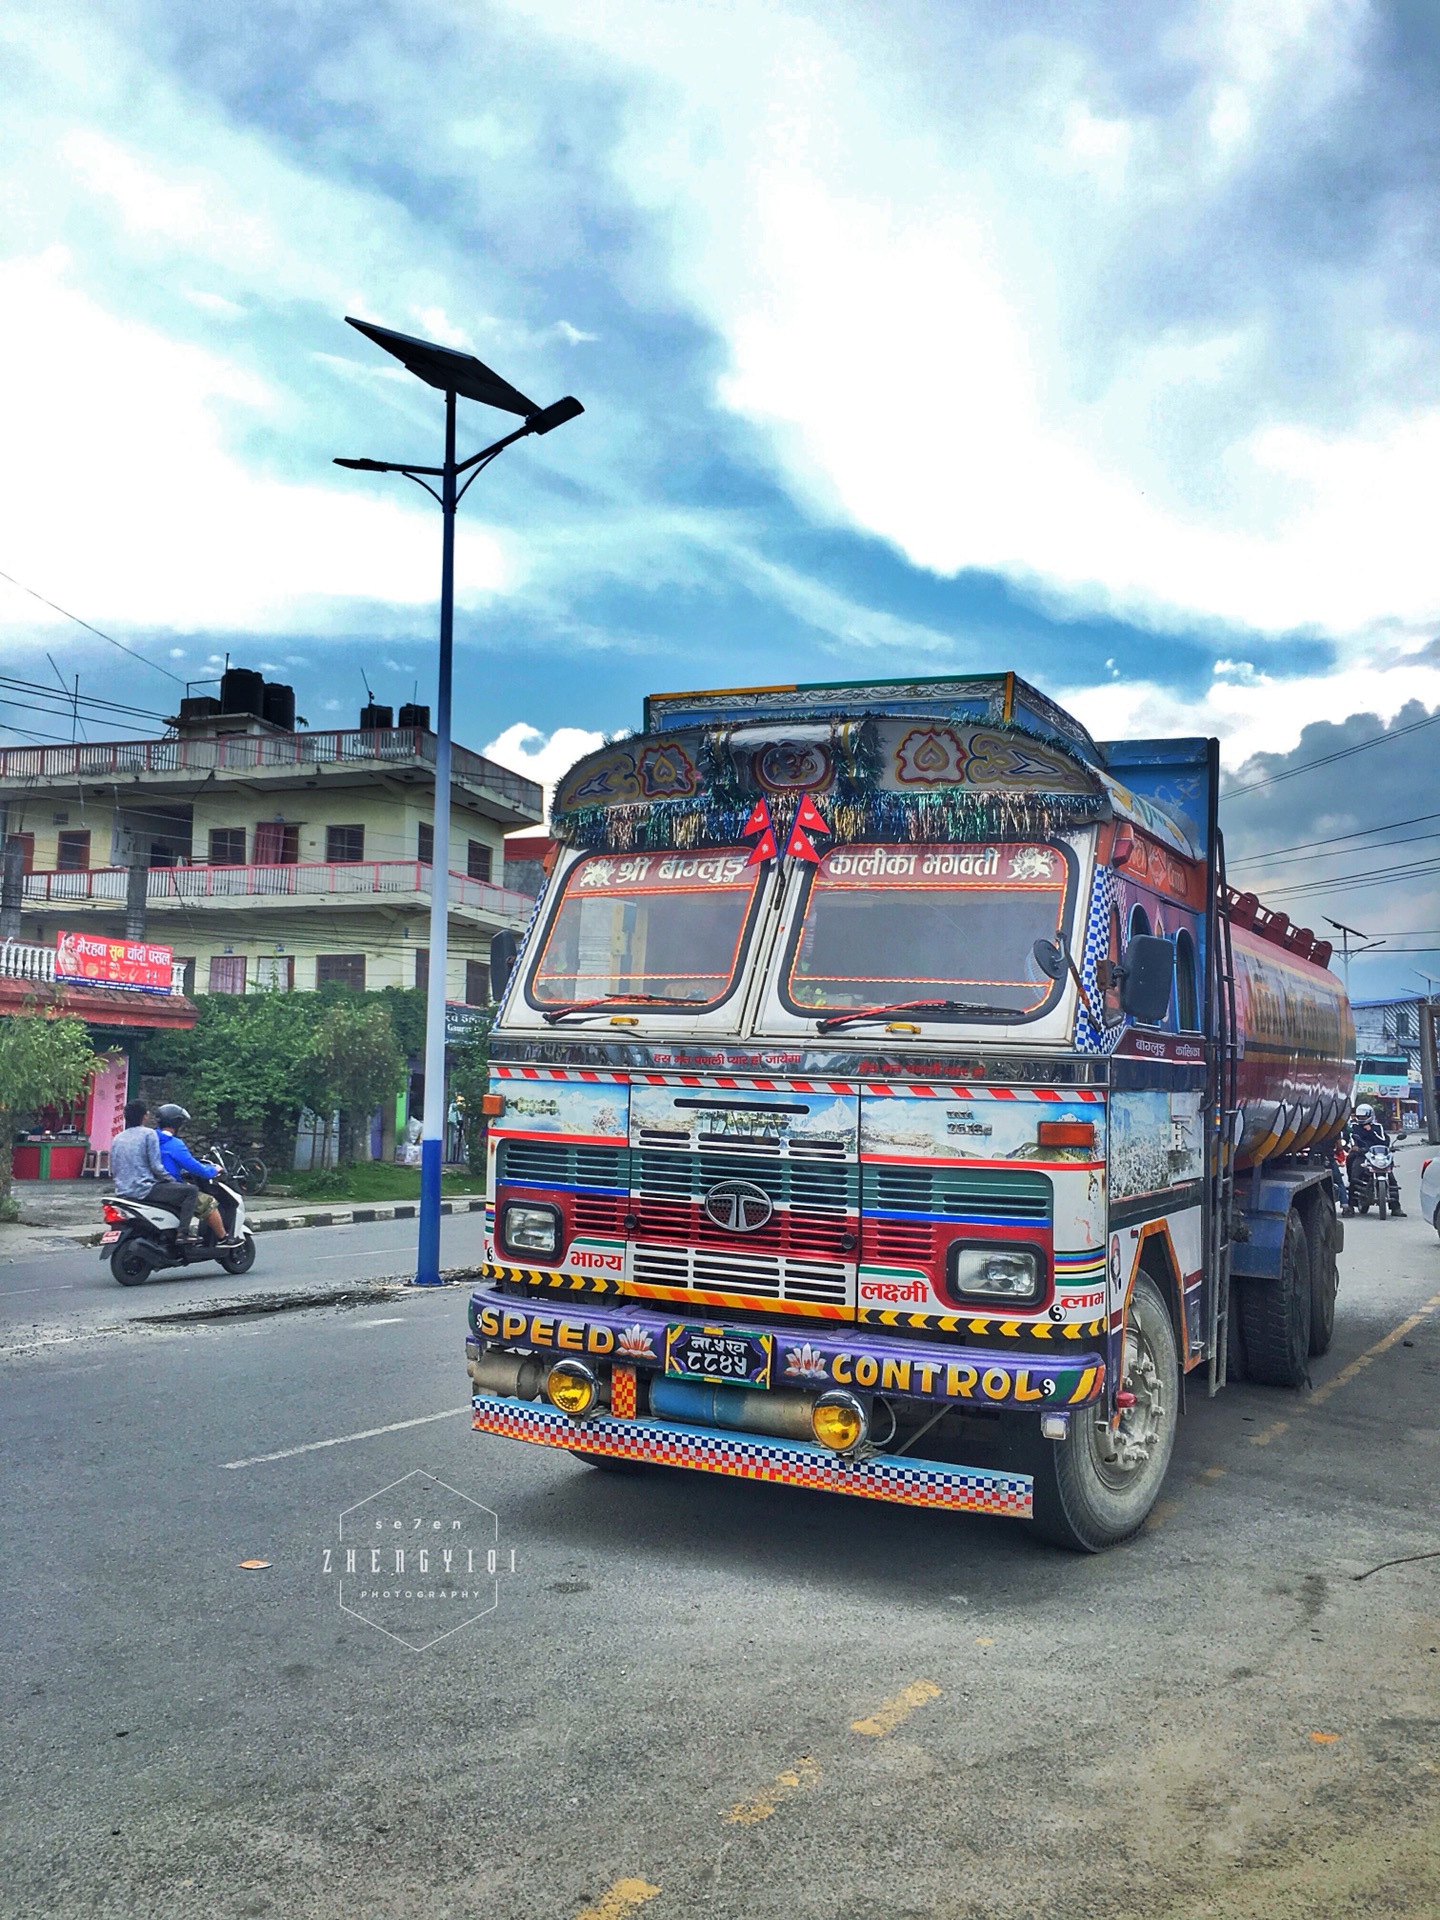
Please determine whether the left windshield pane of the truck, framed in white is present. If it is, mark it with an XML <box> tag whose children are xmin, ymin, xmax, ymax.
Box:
<box><xmin>528</xmin><ymin>847</ymin><xmax>762</xmax><ymax>1012</ymax></box>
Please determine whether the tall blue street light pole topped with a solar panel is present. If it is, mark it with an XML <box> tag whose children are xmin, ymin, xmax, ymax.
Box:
<box><xmin>334</xmin><ymin>321</ymin><xmax>586</xmax><ymax>1286</ymax></box>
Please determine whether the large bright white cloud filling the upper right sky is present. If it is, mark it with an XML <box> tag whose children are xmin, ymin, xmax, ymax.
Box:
<box><xmin>511</xmin><ymin>0</ymin><xmax>1440</xmax><ymax>634</ymax></box>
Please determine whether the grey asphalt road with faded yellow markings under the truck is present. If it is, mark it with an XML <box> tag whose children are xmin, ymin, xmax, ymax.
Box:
<box><xmin>0</xmin><ymin>1219</ymin><xmax>1440</xmax><ymax>1920</ymax></box>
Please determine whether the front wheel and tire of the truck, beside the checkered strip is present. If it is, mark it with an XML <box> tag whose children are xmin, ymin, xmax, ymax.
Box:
<box><xmin>1029</xmin><ymin>1273</ymin><xmax>1181</xmax><ymax>1553</ymax></box>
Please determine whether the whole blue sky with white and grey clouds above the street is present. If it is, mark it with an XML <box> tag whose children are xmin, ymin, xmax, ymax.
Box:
<box><xmin>0</xmin><ymin>0</ymin><xmax>1440</xmax><ymax>995</ymax></box>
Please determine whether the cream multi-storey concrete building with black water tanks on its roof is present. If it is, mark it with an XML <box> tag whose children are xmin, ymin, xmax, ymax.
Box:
<box><xmin>0</xmin><ymin>670</ymin><xmax>543</xmax><ymax>1004</ymax></box>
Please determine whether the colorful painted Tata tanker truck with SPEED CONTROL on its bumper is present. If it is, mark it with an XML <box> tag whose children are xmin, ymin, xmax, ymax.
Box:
<box><xmin>468</xmin><ymin>674</ymin><xmax>1354</xmax><ymax>1551</ymax></box>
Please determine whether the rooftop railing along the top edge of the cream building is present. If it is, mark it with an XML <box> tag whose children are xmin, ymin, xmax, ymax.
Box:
<box><xmin>0</xmin><ymin>726</ymin><xmax>545</xmax><ymax>820</ymax></box>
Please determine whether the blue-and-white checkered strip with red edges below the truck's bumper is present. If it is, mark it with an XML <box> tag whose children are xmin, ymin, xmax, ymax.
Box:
<box><xmin>474</xmin><ymin>1394</ymin><xmax>1035</xmax><ymax>1521</ymax></box>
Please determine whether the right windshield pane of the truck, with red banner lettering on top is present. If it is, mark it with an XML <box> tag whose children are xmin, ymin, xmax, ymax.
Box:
<box><xmin>781</xmin><ymin>843</ymin><xmax>1071</xmax><ymax>1020</ymax></box>
